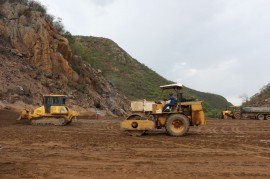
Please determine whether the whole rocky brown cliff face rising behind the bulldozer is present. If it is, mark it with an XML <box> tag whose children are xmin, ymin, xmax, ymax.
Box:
<box><xmin>0</xmin><ymin>0</ymin><xmax>129</xmax><ymax>115</ymax></box>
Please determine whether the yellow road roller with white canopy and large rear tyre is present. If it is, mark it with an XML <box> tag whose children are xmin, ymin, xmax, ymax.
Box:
<box><xmin>120</xmin><ymin>84</ymin><xmax>205</xmax><ymax>137</ymax></box>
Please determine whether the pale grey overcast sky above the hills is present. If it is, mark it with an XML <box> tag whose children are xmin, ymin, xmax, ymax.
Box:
<box><xmin>39</xmin><ymin>0</ymin><xmax>270</xmax><ymax>105</ymax></box>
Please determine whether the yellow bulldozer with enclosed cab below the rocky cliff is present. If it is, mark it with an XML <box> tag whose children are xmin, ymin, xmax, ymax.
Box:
<box><xmin>19</xmin><ymin>94</ymin><xmax>79</xmax><ymax>126</ymax></box>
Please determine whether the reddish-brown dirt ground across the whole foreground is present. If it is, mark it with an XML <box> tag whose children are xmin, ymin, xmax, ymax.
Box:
<box><xmin>0</xmin><ymin>111</ymin><xmax>270</xmax><ymax>179</ymax></box>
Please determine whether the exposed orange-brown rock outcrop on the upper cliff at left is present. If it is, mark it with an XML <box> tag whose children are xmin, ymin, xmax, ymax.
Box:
<box><xmin>0</xmin><ymin>3</ymin><xmax>79</xmax><ymax>81</ymax></box>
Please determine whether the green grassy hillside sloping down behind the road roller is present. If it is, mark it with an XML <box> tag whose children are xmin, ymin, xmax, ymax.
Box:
<box><xmin>67</xmin><ymin>34</ymin><xmax>230</xmax><ymax>117</ymax></box>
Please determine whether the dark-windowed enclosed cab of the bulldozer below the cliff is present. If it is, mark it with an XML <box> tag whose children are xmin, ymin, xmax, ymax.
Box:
<box><xmin>43</xmin><ymin>95</ymin><xmax>67</xmax><ymax>113</ymax></box>
